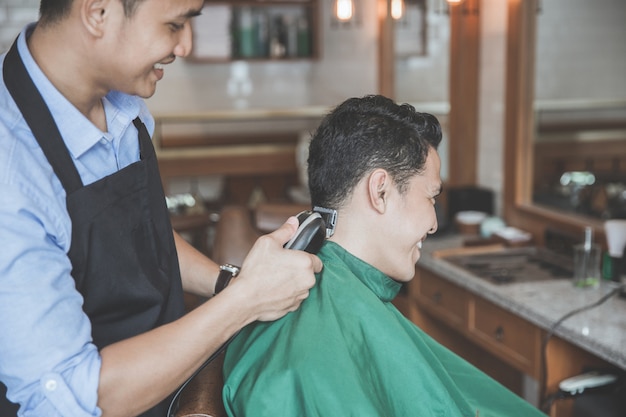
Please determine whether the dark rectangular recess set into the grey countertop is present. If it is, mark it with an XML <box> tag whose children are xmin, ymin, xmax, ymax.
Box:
<box><xmin>442</xmin><ymin>247</ymin><xmax>573</xmax><ymax>285</ymax></box>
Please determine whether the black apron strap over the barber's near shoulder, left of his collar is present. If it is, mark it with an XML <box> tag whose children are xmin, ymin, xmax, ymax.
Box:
<box><xmin>3</xmin><ymin>40</ymin><xmax>83</xmax><ymax>195</ymax></box>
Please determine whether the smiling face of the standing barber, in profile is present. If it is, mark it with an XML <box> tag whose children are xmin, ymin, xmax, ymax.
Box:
<box><xmin>102</xmin><ymin>0</ymin><xmax>203</xmax><ymax>98</ymax></box>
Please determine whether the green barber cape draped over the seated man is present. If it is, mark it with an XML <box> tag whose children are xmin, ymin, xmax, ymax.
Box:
<box><xmin>223</xmin><ymin>241</ymin><xmax>545</xmax><ymax>417</ymax></box>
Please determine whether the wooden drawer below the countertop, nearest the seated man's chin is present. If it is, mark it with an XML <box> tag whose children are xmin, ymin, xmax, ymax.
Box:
<box><xmin>413</xmin><ymin>270</ymin><xmax>469</xmax><ymax>330</ymax></box>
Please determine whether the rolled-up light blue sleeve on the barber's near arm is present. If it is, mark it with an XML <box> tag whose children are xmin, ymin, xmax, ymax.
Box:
<box><xmin>0</xmin><ymin>184</ymin><xmax>101</xmax><ymax>417</ymax></box>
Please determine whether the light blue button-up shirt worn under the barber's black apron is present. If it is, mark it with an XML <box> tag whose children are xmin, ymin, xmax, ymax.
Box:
<box><xmin>0</xmin><ymin>25</ymin><xmax>154</xmax><ymax>417</ymax></box>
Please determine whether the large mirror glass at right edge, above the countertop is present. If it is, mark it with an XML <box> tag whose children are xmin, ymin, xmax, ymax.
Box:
<box><xmin>532</xmin><ymin>0</ymin><xmax>626</xmax><ymax>220</ymax></box>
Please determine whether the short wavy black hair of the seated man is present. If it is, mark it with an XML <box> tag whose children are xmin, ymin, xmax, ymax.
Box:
<box><xmin>308</xmin><ymin>95</ymin><xmax>441</xmax><ymax>209</ymax></box>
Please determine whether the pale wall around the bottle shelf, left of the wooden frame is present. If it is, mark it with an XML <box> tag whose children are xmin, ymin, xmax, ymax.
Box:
<box><xmin>0</xmin><ymin>0</ymin><xmax>377</xmax><ymax>114</ymax></box>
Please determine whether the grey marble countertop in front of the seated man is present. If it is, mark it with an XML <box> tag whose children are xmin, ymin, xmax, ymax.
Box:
<box><xmin>418</xmin><ymin>235</ymin><xmax>626</xmax><ymax>369</ymax></box>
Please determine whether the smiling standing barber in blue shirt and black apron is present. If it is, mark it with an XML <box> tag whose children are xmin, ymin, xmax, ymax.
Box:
<box><xmin>0</xmin><ymin>0</ymin><xmax>322</xmax><ymax>417</ymax></box>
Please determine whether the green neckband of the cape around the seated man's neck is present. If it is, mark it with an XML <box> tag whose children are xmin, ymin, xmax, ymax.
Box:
<box><xmin>320</xmin><ymin>240</ymin><xmax>402</xmax><ymax>302</ymax></box>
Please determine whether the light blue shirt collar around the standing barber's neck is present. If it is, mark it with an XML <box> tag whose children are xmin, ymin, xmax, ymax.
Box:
<box><xmin>17</xmin><ymin>23</ymin><xmax>140</xmax><ymax>159</ymax></box>
